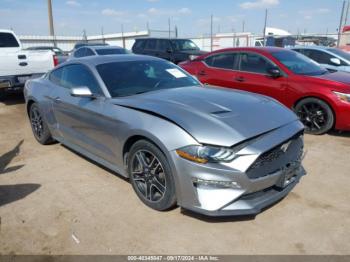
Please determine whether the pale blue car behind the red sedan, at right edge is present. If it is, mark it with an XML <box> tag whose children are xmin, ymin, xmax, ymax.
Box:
<box><xmin>292</xmin><ymin>46</ymin><xmax>350</xmax><ymax>72</ymax></box>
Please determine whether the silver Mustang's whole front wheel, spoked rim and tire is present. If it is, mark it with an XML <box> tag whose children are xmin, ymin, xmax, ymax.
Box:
<box><xmin>128</xmin><ymin>140</ymin><xmax>176</xmax><ymax>211</ymax></box>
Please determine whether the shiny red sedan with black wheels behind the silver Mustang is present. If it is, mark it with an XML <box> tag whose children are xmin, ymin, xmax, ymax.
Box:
<box><xmin>181</xmin><ymin>47</ymin><xmax>350</xmax><ymax>134</ymax></box>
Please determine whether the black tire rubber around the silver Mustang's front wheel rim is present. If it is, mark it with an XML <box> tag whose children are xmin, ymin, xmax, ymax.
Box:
<box><xmin>128</xmin><ymin>140</ymin><xmax>176</xmax><ymax>211</ymax></box>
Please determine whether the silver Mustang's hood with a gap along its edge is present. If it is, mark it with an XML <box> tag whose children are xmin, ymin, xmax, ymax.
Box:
<box><xmin>112</xmin><ymin>86</ymin><xmax>297</xmax><ymax>146</ymax></box>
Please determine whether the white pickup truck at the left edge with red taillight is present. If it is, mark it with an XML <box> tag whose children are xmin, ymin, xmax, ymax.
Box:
<box><xmin>0</xmin><ymin>30</ymin><xmax>58</xmax><ymax>96</ymax></box>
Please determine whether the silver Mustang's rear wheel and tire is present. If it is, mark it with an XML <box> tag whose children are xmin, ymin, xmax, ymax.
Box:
<box><xmin>29</xmin><ymin>103</ymin><xmax>54</xmax><ymax>145</ymax></box>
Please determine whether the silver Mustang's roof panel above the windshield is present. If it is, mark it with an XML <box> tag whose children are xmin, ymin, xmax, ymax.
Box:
<box><xmin>64</xmin><ymin>54</ymin><xmax>164</xmax><ymax>66</ymax></box>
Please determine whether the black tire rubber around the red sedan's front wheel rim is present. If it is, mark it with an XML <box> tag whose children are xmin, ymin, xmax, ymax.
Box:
<box><xmin>294</xmin><ymin>97</ymin><xmax>335</xmax><ymax>135</ymax></box>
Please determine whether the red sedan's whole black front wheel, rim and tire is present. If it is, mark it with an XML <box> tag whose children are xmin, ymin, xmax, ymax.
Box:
<box><xmin>294</xmin><ymin>97</ymin><xmax>335</xmax><ymax>135</ymax></box>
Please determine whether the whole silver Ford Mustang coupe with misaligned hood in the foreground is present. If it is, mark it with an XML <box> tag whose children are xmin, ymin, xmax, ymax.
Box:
<box><xmin>24</xmin><ymin>55</ymin><xmax>305</xmax><ymax>216</ymax></box>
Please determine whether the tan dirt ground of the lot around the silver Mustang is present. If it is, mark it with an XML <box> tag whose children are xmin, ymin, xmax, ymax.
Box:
<box><xmin>0</xmin><ymin>93</ymin><xmax>350</xmax><ymax>254</ymax></box>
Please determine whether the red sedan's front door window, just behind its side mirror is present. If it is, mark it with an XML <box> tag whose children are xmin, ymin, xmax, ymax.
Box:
<box><xmin>240</xmin><ymin>53</ymin><xmax>274</xmax><ymax>74</ymax></box>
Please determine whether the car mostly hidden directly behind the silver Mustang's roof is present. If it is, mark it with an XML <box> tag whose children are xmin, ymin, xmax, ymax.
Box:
<box><xmin>69</xmin><ymin>46</ymin><xmax>130</xmax><ymax>59</ymax></box>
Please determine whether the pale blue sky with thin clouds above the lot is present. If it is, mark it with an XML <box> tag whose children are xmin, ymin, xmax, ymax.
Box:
<box><xmin>0</xmin><ymin>0</ymin><xmax>350</xmax><ymax>37</ymax></box>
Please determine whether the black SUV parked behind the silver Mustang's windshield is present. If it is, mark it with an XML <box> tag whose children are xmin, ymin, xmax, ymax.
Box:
<box><xmin>132</xmin><ymin>38</ymin><xmax>205</xmax><ymax>64</ymax></box>
